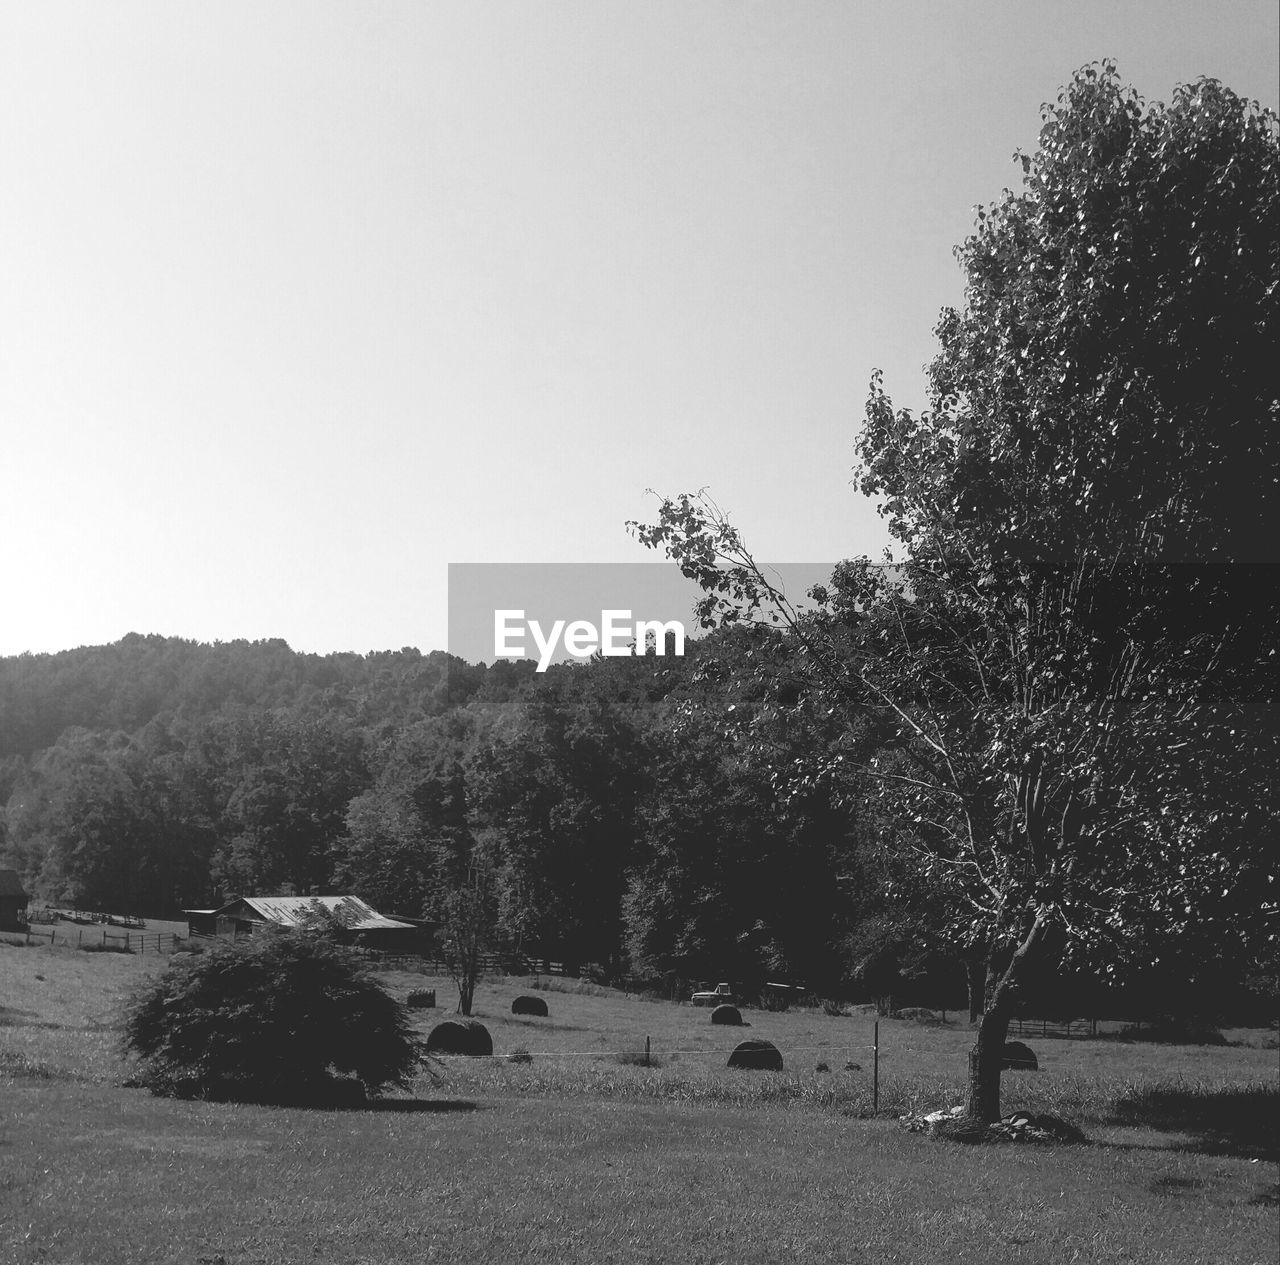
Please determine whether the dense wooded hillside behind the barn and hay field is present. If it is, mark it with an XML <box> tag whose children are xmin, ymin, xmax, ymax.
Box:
<box><xmin>0</xmin><ymin>622</ymin><xmax>868</xmax><ymax>991</ymax></box>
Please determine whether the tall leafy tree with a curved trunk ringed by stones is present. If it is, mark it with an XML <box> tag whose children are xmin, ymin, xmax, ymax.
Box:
<box><xmin>641</xmin><ymin>65</ymin><xmax>1280</xmax><ymax>1120</ymax></box>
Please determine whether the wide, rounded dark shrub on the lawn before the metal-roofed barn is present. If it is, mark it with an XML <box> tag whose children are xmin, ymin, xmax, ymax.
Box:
<box><xmin>124</xmin><ymin>932</ymin><xmax>421</xmax><ymax>1104</ymax></box>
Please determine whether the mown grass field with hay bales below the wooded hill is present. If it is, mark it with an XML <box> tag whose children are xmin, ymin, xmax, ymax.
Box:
<box><xmin>0</xmin><ymin>945</ymin><xmax>1280</xmax><ymax>1265</ymax></box>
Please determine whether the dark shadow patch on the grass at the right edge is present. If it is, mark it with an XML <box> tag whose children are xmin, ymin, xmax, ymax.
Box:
<box><xmin>1112</xmin><ymin>1084</ymin><xmax>1280</xmax><ymax>1160</ymax></box>
